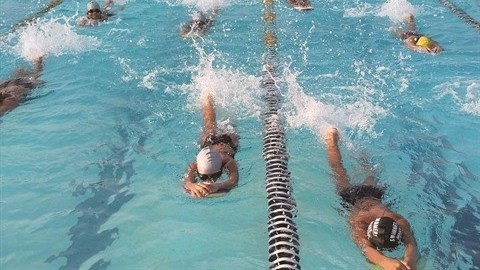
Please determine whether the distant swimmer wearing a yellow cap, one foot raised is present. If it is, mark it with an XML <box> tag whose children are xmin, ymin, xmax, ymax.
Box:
<box><xmin>395</xmin><ymin>13</ymin><xmax>443</xmax><ymax>54</ymax></box>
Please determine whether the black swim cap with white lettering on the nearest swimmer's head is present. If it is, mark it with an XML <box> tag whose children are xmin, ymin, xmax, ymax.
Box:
<box><xmin>367</xmin><ymin>217</ymin><xmax>402</xmax><ymax>249</ymax></box>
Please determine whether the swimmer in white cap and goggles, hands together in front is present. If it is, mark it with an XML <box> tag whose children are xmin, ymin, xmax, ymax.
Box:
<box><xmin>183</xmin><ymin>94</ymin><xmax>239</xmax><ymax>198</ymax></box>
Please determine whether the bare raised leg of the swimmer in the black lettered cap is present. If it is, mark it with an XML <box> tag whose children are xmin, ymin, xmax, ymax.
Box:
<box><xmin>325</xmin><ymin>127</ymin><xmax>350</xmax><ymax>192</ymax></box>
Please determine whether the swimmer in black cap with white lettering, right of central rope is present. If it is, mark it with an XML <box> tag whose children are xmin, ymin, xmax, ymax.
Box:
<box><xmin>325</xmin><ymin>128</ymin><xmax>418</xmax><ymax>270</ymax></box>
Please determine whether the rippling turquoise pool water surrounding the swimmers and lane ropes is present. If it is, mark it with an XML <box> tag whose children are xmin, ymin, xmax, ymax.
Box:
<box><xmin>0</xmin><ymin>0</ymin><xmax>480</xmax><ymax>269</ymax></box>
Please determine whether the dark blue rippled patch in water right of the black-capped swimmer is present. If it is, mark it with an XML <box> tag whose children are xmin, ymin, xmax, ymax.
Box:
<box><xmin>401</xmin><ymin>112</ymin><xmax>480</xmax><ymax>269</ymax></box>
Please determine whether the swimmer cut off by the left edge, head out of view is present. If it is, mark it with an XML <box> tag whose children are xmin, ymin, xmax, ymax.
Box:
<box><xmin>0</xmin><ymin>57</ymin><xmax>43</xmax><ymax>116</ymax></box>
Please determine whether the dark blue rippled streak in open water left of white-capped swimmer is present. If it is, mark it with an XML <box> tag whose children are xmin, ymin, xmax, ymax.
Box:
<box><xmin>47</xmin><ymin>128</ymin><xmax>135</xmax><ymax>269</ymax></box>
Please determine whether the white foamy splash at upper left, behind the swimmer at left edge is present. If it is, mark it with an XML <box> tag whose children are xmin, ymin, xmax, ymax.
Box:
<box><xmin>14</xmin><ymin>19</ymin><xmax>100</xmax><ymax>60</ymax></box>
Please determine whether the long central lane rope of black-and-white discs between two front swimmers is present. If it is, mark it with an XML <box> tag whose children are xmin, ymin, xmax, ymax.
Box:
<box><xmin>261</xmin><ymin>0</ymin><xmax>301</xmax><ymax>270</ymax></box>
